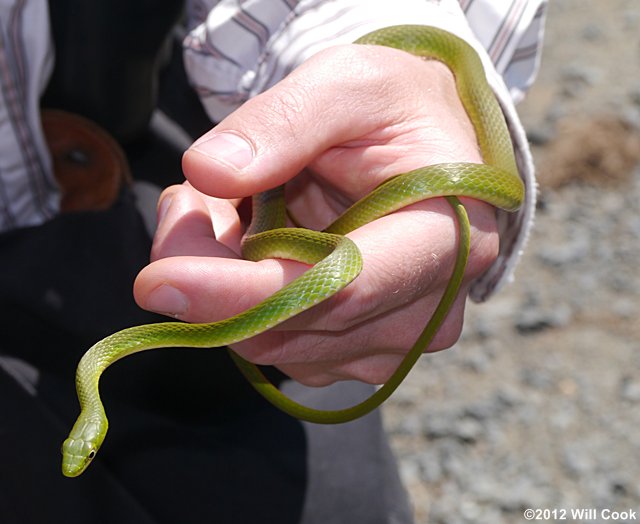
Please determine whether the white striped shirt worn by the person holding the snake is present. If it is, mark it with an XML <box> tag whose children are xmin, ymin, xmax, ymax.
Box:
<box><xmin>0</xmin><ymin>0</ymin><xmax>547</xmax><ymax>299</ymax></box>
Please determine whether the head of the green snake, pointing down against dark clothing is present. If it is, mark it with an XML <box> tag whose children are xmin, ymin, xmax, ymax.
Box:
<box><xmin>62</xmin><ymin>416</ymin><xmax>107</xmax><ymax>477</ymax></box>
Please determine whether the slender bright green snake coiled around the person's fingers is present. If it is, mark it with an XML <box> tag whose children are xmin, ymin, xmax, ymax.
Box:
<box><xmin>62</xmin><ymin>26</ymin><xmax>524</xmax><ymax>477</ymax></box>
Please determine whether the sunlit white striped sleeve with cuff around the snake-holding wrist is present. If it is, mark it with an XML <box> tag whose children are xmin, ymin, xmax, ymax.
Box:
<box><xmin>185</xmin><ymin>0</ymin><xmax>546</xmax><ymax>301</ymax></box>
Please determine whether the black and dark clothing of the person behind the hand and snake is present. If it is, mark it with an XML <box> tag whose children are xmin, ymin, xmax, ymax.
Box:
<box><xmin>0</xmin><ymin>0</ymin><xmax>411</xmax><ymax>524</ymax></box>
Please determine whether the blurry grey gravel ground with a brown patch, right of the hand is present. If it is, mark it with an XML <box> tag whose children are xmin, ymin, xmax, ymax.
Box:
<box><xmin>385</xmin><ymin>0</ymin><xmax>640</xmax><ymax>524</ymax></box>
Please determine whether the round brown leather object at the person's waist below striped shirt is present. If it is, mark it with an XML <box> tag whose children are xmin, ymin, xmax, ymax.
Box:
<box><xmin>42</xmin><ymin>109</ymin><xmax>131</xmax><ymax>213</ymax></box>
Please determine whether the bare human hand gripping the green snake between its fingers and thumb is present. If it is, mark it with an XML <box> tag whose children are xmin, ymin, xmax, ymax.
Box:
<box><xmin>134</xmin><ymin>45</ymin><xmax>498</xmax><ymax>385</ymax></box>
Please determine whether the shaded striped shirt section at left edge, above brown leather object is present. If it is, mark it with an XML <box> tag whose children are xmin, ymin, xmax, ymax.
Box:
<box><xmin>0</xmin><ymin>0</ymin><xmax>59</xmax><ymax>231</ymax></box>
